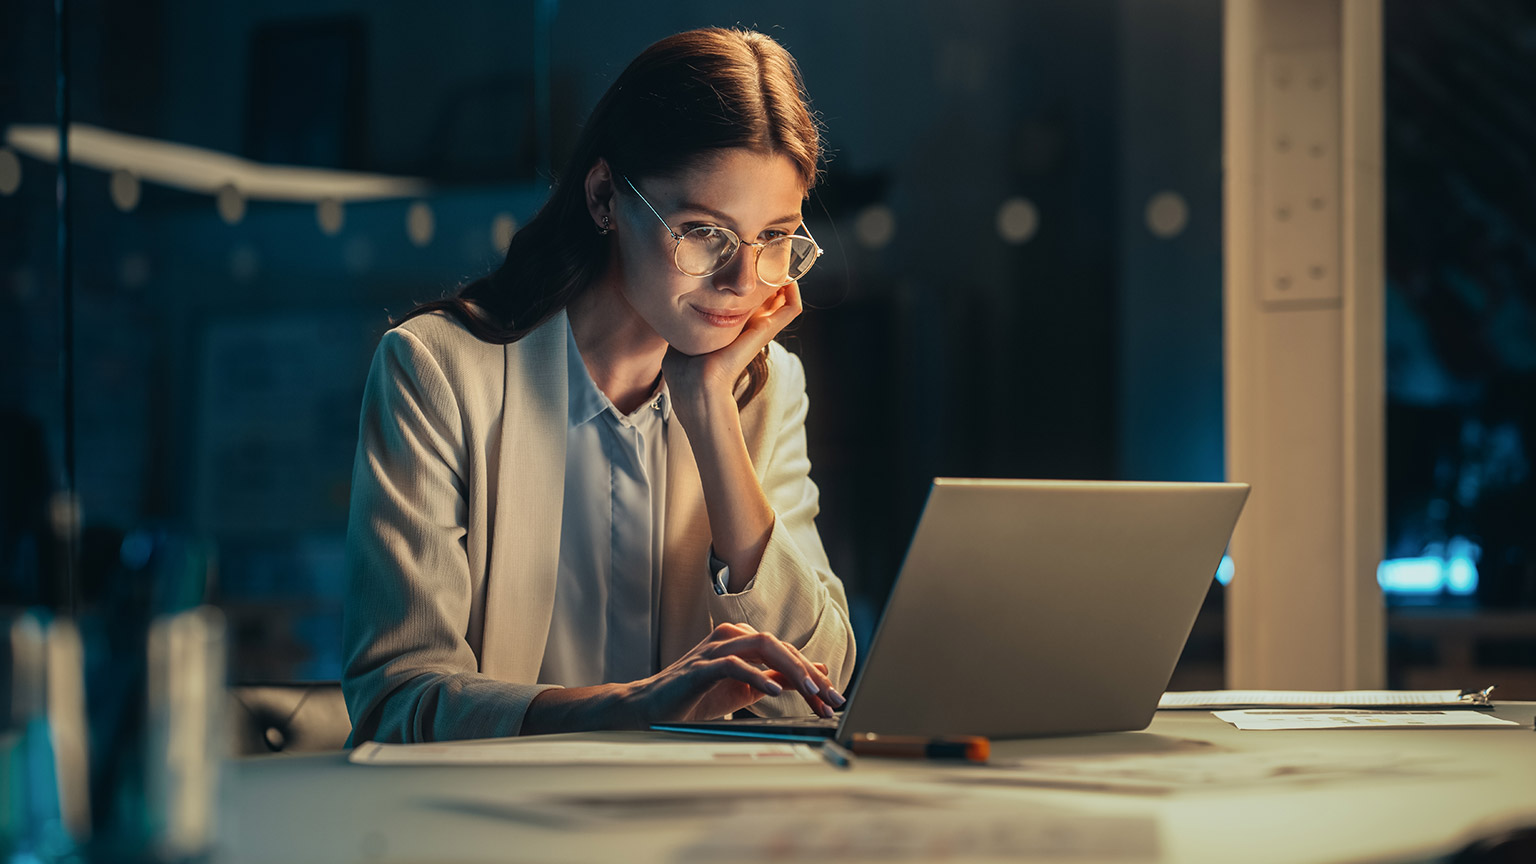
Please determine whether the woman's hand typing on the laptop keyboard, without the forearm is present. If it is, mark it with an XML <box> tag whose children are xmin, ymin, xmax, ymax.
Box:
<box><xmin>628</xmin><ymin>614</ymin><xmax>846</xmax><ymax>729</ymax></box>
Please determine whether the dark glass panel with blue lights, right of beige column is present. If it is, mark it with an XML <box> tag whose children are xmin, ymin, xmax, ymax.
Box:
<box><xmin>1379</xmin><ymin>2</ymin><xmax>1536</xmax><ymax>700</ymax></box>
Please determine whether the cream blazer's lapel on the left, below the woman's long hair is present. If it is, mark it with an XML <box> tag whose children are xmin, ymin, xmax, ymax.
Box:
<box><xmin>479</xmin><ymin>312</ymin><xmax>570</xmax><ymax>683</ymax></box>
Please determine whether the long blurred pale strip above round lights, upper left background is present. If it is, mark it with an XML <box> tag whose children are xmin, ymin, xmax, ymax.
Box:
<box><xmin>0</xmin><ymin>123</ymin><xmax>427</xmax><ymax>201</ymax></box>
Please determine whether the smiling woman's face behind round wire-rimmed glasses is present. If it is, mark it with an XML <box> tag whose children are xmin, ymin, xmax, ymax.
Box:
<box><xmin>611</xmin><ymin>149</ymin><xmax>805</xmax><ymax>355</ymax></box>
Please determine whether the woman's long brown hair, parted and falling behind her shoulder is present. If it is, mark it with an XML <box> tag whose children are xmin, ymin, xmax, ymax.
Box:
<box><xmin>396</xmin><ymin>28</ymin><xmax>822</xmax><ymax>406</ymax></box>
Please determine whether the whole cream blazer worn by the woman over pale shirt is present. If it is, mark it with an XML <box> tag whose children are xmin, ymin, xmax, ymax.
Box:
<box><xmin>343</xmin><ymin>305</ymin><xmax>854</xmax><ymax>743</ymax></box>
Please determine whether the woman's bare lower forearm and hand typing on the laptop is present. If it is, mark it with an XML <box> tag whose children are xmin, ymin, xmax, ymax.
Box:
<box><xmin>522</xmin><ymin>624</ymin><xmax>846</xmax><ymax>735</ymax></box>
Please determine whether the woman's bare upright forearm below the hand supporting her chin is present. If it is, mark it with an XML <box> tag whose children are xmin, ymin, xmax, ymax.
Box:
<box><xmin>687</xmin><ymin>384</ymin><xmax>774</xmax><ymax>593</ymax></box>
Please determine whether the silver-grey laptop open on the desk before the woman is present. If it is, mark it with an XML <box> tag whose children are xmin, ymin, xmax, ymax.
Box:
<box><xmin>651</xmin><ymin>478</ymin><xmax>1249</xmax><ymax>741</ymax></box>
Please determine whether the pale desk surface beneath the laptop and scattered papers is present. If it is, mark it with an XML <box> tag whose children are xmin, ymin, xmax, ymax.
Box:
<box><xmin>221</xmin><ymin>703</ymin><xmax>1536</xmax><ymax>864</ymax></box>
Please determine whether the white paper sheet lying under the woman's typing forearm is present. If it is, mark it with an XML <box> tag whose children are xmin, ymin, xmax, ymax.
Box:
<box><xmin>347</xmin><ymin>739</ymin><xmax>822</xmax><ymax>766</ymax></box>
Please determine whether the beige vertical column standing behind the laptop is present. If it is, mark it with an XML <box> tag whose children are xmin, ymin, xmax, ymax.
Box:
<box><xmin>1224</xmin><ymin>0</ymin><xmax>1384</xmax><ymax>689</ymax></box>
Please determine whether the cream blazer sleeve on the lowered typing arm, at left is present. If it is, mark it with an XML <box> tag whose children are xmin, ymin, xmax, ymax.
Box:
<box><xmin>341</xmin><ymin>329</ymin><xmax>548</xmax><ymax>744</ymax></box>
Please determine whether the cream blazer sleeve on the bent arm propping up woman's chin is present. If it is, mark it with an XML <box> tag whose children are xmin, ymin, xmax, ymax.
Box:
<box><xmin>707</xmin><ymin>342</ymin><xmax>854</xmax><ymax>715</ymax></box>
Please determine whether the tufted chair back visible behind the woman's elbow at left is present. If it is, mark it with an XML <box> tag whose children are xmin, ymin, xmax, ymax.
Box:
<box><xmin>229</xmin><ymin>681</ymin><xmax>352</xmax><ymax>756</ymax></box>
